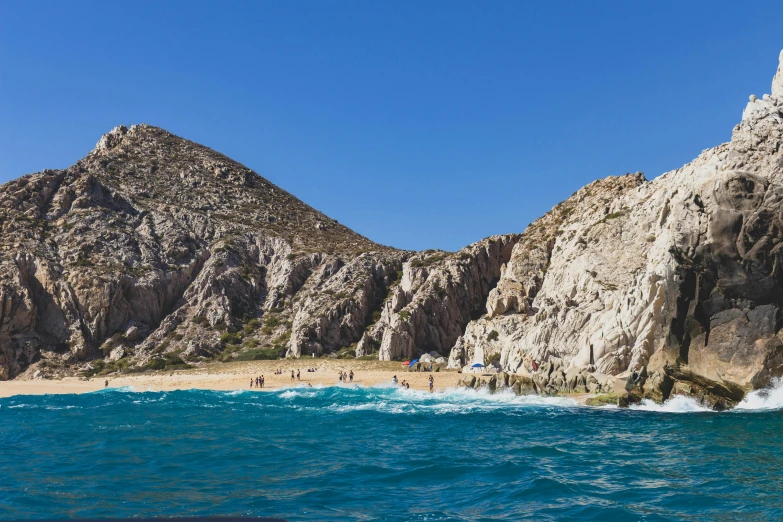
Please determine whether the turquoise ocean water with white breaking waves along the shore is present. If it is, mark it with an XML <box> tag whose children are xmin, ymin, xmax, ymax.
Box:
<box><xmin>0</xmin><ymin>380</ymin><xmax>783</xmax><ymax>521</ymax></box>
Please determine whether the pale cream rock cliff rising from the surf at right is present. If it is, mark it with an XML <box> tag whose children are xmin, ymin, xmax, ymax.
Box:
<box><xmin>450</xmin><ymin>49</ymin><xmax>783</xmax><ymax>404</ymax></box>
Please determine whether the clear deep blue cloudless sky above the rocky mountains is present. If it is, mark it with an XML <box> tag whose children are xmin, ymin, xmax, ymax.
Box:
<box><xmin>0</xmin><ymin>0</ymin><xmax>783</xmax><ymax>250</ymax></box>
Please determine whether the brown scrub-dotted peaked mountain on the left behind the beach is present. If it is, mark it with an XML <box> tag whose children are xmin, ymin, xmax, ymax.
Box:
<box><xmin>0</xmin><ymin>125</ymin><xmax>410</xmax><ymax>379</ymax></box>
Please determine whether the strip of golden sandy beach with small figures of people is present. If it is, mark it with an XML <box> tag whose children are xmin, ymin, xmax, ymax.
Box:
<box><xmin>0</xmin><ymin>358</ymin><xmax>472</xmax><ymax>397</ymax></box>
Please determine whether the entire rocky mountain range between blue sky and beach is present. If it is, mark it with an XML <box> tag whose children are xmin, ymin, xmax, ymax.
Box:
<box><xmin>0</xmin><ymin>48</ymin><xmax>783</xmax><ymax>407</ymax></box>
